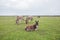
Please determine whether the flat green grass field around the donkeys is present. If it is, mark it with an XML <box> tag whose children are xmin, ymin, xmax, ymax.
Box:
<box><xmin>0</xmin><ymin>16</ymin><xmax>60</xmax><ymax>40</ymax></box>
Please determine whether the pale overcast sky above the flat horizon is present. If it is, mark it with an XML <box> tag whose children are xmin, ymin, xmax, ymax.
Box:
<box><xmin>0</xmin><ymin>0</ymin><xmax>60</xmax><ymax>15</ymax></box>
